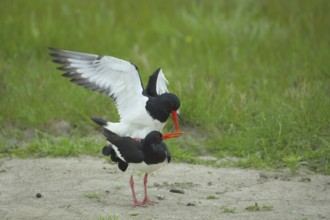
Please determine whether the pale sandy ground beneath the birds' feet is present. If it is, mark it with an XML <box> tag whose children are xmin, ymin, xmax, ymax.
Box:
<box><xmin>0</xmin><ymin>157</ymin><xmax>330</xmax><ymax>220</ymax></box>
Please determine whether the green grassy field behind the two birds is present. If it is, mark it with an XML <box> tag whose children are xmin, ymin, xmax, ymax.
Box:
<box><xmin>0</xmin><ymin>0</ymin><xmax>330</xmax><ymax>174</ymax></box>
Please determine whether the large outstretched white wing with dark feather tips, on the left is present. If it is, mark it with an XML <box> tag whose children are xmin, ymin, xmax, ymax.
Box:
<box><xmin>49</xmin><ymin>48</ymin><xmax>147</xmax><ymax>119</ymax></box>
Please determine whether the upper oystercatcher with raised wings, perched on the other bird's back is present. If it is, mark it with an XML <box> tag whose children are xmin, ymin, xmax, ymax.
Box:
<box><xmin>49</xmin><ymin>48</ymin><xmax>182</xmax><ymax>139</ymax></box>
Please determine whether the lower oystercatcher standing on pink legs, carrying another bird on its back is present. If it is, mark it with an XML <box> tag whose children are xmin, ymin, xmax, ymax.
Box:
<box><xmin>102</xmin><ymin>126</ymin><xmax>171</xmax><ymax>206</ymax></box>
